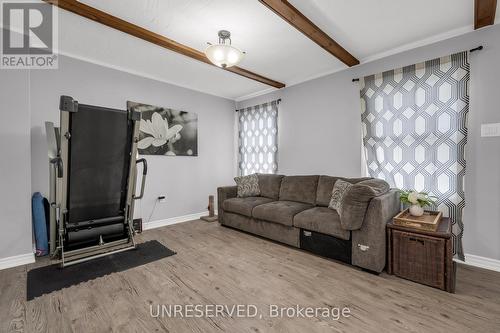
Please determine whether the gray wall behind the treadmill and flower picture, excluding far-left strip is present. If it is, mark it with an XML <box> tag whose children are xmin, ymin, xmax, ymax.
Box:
<box><xmin>30</xmin><ymin>56</ymin><xmax>236</xmax><ymax>222</ymax></box>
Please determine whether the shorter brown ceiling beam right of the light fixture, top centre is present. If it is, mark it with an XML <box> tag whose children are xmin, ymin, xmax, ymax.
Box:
<box><xmin>259</xmin><ymin>0</ymin><xmax>359</xmax><ymax>67</ymax></box>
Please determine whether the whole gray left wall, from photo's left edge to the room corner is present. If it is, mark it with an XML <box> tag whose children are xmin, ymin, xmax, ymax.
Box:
<box><xmin>0</xmin><ymin>50</ymin><xmax>236</xmax><ymax>258</ymax></box>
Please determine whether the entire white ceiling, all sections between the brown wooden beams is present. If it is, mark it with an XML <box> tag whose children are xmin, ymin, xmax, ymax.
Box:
<box><xmin>53</xmin><ymin>0</ymin><xmax>500</xmax><ymax>99</ymax></box>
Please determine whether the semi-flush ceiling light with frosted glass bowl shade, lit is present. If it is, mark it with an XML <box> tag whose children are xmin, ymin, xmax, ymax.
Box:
<box><xmin>205</xmin><ymin>30</ymin><xmax>245</xmax><ymax>68</ymax></box>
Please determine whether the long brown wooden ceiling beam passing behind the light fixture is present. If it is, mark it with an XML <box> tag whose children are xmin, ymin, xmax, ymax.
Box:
<box><xmin>43</xmin><ymin>0</ymin><xmax>285</xmax><ymax>88</ymax></box>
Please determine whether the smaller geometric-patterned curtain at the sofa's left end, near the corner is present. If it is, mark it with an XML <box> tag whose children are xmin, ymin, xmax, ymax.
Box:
<box><xmin>238</xmin><ymin>101</ymin><xmax>278</xmax><ymax>176</ymax></box>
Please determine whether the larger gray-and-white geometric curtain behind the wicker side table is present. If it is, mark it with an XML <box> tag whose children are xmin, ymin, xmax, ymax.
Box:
<box><xmin>360</xmin><ymin>52</ymin><xmax>470</xmax><ymax>260</ymax></box>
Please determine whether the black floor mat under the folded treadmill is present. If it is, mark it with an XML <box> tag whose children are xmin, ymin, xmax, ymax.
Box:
<box><xmin>26</xmin><ymin>240</ymin><xmax>175</xmax><ymax>301</ymax></box>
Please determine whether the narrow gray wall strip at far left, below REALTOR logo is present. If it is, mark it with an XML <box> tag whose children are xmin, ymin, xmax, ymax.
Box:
<box><xmin>0</xmin><ymin>70</ymin><xmax>32</xmax><ymax>258</ymax></box>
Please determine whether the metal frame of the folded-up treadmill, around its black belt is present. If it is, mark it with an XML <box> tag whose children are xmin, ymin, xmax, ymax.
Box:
<box><xmin>47</xmin><ymin>96</ymin><xmax>145</xmax><ymax>267</ymax></box>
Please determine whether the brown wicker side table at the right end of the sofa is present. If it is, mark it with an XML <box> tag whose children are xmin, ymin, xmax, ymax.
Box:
<box><xmin>387</xmin><ymin>218</ymin><xmax>456</xmax><ymax>293</ymax></box>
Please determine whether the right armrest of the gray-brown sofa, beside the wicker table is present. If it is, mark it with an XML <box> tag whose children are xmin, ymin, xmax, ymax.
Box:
<box><xmin>352</xmin><ymin>190</ymin><xmax>401</xmax><ymax>272</ymax></box>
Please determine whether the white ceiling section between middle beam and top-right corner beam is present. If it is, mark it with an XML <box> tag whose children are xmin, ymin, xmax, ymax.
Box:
<box><xmin>290</xmin><ymin>0</ymin><xmax>480</xmax><ymax>62</ymax></box>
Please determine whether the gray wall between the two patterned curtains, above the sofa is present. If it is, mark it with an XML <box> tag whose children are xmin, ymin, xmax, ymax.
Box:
<box><xmin>238</xmin><ymin>71</ymin><xmax>361</xmax><ymax>176</ymax></box>
